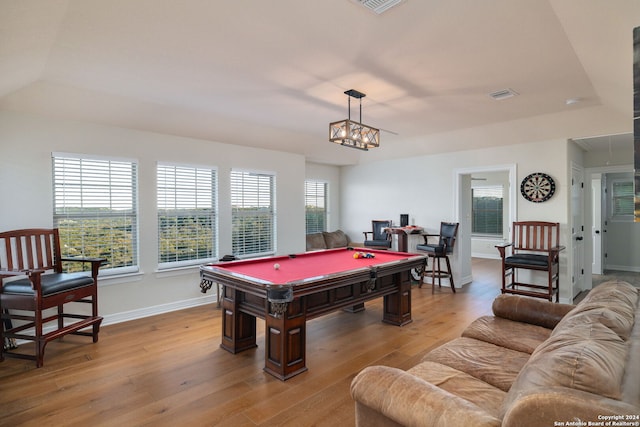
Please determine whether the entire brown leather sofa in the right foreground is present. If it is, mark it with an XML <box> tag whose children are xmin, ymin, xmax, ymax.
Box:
<box><xmin>351</xmin><ymin>282</ymin><xmax>640</xmax><ymax>427</ymax></box>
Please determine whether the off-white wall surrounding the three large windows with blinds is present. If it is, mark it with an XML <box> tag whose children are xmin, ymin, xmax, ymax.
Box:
<box><xmin>0</xmin><ymin>112</ymin><xmax>305</xmax><ymax>323</ymax></box>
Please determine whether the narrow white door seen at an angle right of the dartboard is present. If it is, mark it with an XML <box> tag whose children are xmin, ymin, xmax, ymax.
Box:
<box><xmin>568</xmin><ymin>164</ymin><xmax>584</xmax><ymax>300</ymax></box>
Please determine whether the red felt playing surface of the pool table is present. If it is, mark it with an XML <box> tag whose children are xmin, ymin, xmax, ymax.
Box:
<box><xmin>208</xmin><ymin>248</ymin><xmax>415</xmax><ymax>284</ymax></box>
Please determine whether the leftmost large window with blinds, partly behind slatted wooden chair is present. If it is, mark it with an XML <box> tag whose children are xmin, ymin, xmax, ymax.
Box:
<box><xmin>52</xmin><ymin>153</ymin><xmax>138</xmax><ymax>274</ymax></box>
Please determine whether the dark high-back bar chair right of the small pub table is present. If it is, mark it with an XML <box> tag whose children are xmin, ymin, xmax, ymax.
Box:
<box><xmin>416</xmin><ymin>222</ymin><xmax>459</xmax><ymax>294</ymax></box>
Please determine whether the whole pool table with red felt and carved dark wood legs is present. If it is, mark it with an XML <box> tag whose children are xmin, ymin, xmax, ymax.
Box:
<box><xmin>200</xmin><ymin>248</ymin><xmax>425</xmax><ymax>381</ymax></box>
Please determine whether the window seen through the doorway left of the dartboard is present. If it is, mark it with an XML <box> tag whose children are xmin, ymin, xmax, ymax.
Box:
<box><xmin>471</xmin><ymin>186</ymin><xmax>503</xmax><ymax>237</ymax></box>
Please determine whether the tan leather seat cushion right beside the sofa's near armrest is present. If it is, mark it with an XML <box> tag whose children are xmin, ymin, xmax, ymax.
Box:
<box><xmin>407</xmin><ymin>361</ymin><xmax>507</xmax><ymax>417</ymax></box>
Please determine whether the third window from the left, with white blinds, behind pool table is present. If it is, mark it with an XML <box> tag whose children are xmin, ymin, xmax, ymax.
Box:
<box><xmin>231</xmin><ymin>171</ymin><xmax>275</xmax><ymax>256</ymax></box>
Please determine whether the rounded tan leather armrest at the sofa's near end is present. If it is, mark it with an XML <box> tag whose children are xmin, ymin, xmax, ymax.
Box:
<box><xmin>351</xmin><ymin>366</ymin><xmax>501</xmax><ymax>427</ymax></box>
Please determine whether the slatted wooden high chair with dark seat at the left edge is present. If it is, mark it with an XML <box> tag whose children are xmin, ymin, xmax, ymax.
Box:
<box><xmin>0</xmin><ymin>229</ymin><xmax>104</xmax><ymax>367</ymax></box>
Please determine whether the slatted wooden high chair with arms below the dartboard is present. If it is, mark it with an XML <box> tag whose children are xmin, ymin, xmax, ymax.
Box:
<box><xmin>496</xmin><ymin>221</ymin><xmax>565</xmax><ymax>302</ymax></box>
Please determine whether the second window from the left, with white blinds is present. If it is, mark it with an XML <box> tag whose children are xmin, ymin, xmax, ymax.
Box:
<box><xmin>157</xmin><ymin>164</ymin><xmax>217</xmax><ymax>269</ymax></box>
